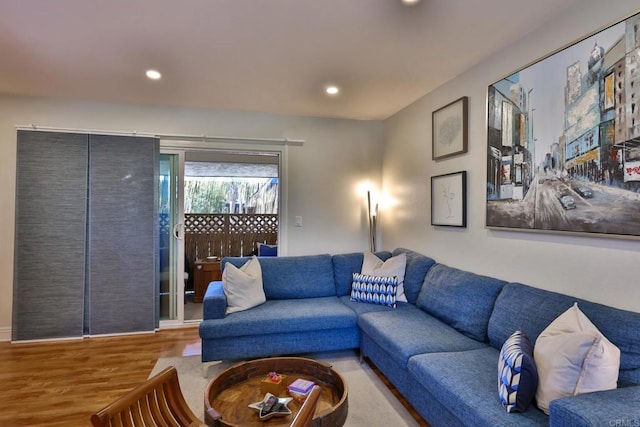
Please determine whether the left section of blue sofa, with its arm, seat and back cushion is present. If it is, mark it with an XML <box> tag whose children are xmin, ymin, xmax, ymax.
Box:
<box><xmin>200</xmin><ymin>255</ymin><xmax>360</xmax><ymax>362</ymax></box>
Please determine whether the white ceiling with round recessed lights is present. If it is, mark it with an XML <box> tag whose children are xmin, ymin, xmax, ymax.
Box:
<box><xmin>0</xmin><ymin>0</ymin><xmax>580</xmax><ymax>119</ymax></box>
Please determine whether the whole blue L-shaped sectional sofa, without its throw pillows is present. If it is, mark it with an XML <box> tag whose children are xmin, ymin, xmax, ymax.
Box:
<box><xmin>200</xmin><ymin>249</ymin><xmax>640</xmax><ymax>426</ymax></box>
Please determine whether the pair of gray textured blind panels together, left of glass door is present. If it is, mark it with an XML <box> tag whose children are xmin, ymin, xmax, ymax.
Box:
<box><xmin>12</xmin><ymin>131</ymin><xmax>159</xmax><ymax>340</ymax></box>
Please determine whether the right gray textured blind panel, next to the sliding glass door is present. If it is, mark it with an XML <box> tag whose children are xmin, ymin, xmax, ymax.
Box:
<box><xmin>85</xmin><ymin>135</ymin><xmax>159</xmax><ymax>335</ymax></box>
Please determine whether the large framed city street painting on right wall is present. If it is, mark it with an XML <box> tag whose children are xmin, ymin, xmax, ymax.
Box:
<box><xmin>486</xmin><ymin>10</ymin><xmax>640</xmax><ymax>238</ymax></box>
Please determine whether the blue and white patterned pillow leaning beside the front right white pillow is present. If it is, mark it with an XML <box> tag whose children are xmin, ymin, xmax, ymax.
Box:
<box><xmin>498</xmin><ymin>331</ymin><xmax>538</xmax><ymax>412</ymax></box>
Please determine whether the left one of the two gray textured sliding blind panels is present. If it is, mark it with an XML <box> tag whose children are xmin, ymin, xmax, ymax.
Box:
<box><xmin>12</xmin><ymin>131</ymin><xmax>88</xmax><ymax>340</ymax></box>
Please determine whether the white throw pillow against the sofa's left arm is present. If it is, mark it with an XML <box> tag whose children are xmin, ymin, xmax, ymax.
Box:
<box><xmin>222</xmin><ymin>256</ymin><xmax>267</xmax><ymax>314</ymax></box>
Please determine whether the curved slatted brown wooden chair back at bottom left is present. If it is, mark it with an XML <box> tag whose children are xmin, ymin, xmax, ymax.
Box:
<box><xmin>91</xmin><ymin>366</ymin><xmax>205</xmax><ymax>427</ymax></box>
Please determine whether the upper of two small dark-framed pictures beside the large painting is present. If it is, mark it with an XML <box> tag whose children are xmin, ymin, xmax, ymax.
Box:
<box><xmin>431</xmin><ymin>96</ymin><xmax>468</xmax><ymax>160</ymax></box>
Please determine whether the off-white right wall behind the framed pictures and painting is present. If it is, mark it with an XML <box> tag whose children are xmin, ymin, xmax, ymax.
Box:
<box><xmin>381</xmin><ymin>0</ymin><xmax>640</xmax><ymax>311</ymax></box>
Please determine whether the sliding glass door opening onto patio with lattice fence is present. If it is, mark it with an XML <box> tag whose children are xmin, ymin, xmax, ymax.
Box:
<box><xmin>157</xmin><ymin>141</ymin><xmax>286</xmax><ymax>327</ymax></box>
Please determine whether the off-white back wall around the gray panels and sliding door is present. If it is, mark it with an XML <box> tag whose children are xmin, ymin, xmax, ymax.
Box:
<box><xmin>0</xmin><ymin>96</ymin><xmax>383</xmax><ymax>340</ymax></box>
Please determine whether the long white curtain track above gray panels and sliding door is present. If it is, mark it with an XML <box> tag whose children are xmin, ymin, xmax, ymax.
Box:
<box><xmin>15</xmin><ymin>124</ymin><xmax>304</xmax><ymax>146</ymax></box>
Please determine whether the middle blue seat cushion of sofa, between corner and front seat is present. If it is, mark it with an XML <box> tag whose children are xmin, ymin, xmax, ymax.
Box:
<box><xmin>358</xmin><ymin>304</ymin><xmax>484</xmax><ymax>370</ymax></box>
